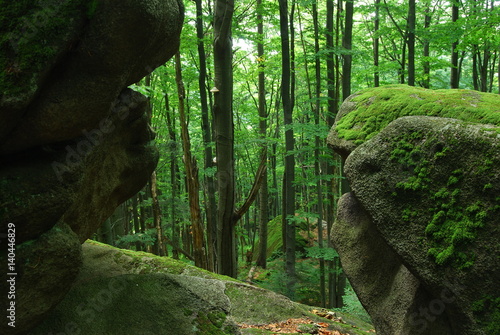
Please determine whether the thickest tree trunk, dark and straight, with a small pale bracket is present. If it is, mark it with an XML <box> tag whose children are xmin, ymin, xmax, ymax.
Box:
<box><xmin>213</xmin><ymin>0</ymin><xmax>238</xmax><ymax>277</ymax></box>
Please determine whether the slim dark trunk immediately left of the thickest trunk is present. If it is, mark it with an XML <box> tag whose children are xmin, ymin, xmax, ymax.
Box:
<box><xmin>196</xmin><ymin>0</ymin><xmax>217</xmax><ymax>271</ymax></box>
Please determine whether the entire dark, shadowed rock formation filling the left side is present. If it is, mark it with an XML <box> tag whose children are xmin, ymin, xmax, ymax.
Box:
<box><xmin>0</xmin><ymin>0</ymin><xmax>183</xmax><ymax>334</ymax></box>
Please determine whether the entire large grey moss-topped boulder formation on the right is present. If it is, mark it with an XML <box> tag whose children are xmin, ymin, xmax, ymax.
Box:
<box><xmin>330</xmin><ymin>86</ymin><xmax>500</xmax><ymax>335</ymax></box>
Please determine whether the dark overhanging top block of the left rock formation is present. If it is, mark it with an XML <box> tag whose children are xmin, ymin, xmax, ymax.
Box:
<box><xmin>0</xmin><ymin>0</ymin><xmax>183</xmax><ymax>153</ymax></box>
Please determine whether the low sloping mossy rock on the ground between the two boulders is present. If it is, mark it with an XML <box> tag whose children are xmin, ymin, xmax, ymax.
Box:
<box><xmin>29</xmin><ymin>241</ymin><xmax>370</xmax><ymax>335</ymax></box>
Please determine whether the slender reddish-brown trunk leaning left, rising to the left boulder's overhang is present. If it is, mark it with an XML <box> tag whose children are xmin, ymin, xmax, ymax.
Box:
<box><xmin>175</xmin><ymin>53</ymin><xmax>207</xmax><ymax>269</ymax></box>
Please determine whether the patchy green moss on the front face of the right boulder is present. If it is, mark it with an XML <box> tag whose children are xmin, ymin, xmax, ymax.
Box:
<box><xmin>391</xmin><ymin>119</ymin><xmax>500</xmax><ymax>269</ymax></box>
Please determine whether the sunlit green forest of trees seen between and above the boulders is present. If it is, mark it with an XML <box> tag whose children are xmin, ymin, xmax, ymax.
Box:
<box><xmin>94</xmin><ymin>0</ymin><xmax>500</xmax><ymax>307</ymax></box>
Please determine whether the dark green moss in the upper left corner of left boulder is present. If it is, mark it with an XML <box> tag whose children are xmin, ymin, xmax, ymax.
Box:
<box><xmin>0</xmin><ymin>0</ymin><xmax>88</xmax><ymax>100</ymax></box>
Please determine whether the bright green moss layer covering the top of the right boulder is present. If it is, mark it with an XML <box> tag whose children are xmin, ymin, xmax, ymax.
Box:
<box><xmin>335</xmin><ymin>85</ymin><xmax>500</xmax><ymax>145</ymax></box>
